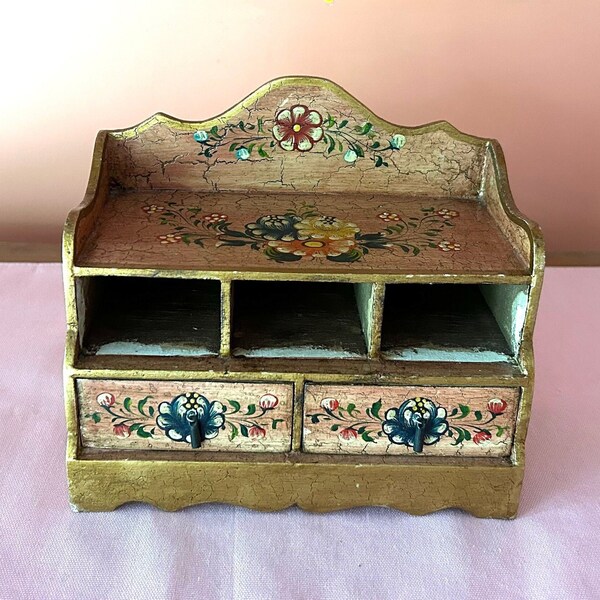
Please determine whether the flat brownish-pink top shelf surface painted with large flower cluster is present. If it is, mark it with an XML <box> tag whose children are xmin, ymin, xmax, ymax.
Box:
<box><xmin>75</xmin><ymin>190</ymin><xmax>529</xmax><ymax>276</ymax></box>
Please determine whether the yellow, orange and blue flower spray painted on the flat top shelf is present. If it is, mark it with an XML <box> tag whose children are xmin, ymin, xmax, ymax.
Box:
<box><xmin>142</xmin><ymin>202</ymin><xmax>460</xmax><ymax>262</ymax></box>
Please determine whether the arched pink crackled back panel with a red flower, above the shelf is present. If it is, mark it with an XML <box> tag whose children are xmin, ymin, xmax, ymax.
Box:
<box><xmin>109</xmin><ymin>82</ymin><xmax>484</xmax><ymax>198</ymax></box>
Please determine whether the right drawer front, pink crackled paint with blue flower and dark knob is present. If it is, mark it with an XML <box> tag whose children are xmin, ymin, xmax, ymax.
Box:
<box><xmin>302</xmin><ymin>384</ymin><xmax>520</xmax><ymax>457</ymax></box>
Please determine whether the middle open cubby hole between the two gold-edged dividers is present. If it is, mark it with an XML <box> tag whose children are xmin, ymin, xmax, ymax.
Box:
<box><xmin>232</xmin><ymin>281</ymin><xmax>368</xmax><ymax>358</ymax></box>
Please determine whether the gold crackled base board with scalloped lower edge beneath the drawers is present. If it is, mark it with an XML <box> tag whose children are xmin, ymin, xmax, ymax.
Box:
<box><xmin>67</xmin><ymin>453</ymin><xmax>523</xmax><ymax>519</ymax></box>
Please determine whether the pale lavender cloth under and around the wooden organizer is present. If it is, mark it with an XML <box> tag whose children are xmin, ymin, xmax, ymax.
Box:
<box><xmin>0</xmin><ymin>264</ymin><xmax>600</xmax><ymax>600</ymax></box>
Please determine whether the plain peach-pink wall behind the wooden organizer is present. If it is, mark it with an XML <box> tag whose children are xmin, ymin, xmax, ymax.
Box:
<box><xmin>0</xmin><ymin>0</ymin><xmax>600</xmax><ymax>251</ymax></box>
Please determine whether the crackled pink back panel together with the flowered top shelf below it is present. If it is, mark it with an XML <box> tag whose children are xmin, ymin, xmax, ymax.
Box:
<box><xmin>76</xmin><ymin>80</ymin><xmax>528</xmax><ymax>275</ymax></box>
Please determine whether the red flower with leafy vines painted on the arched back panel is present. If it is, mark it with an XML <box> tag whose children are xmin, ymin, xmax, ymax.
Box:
<box><xmin>193</xmin><ymin>104</ymin><xmax>406</xmax><ymax>167</ymax></box>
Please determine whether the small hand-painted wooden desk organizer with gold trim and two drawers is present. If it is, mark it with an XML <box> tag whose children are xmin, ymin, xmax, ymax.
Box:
<box><xmin>64</xmin><ymin>77</ymin><xmax>544</xmax><ymax>517</ymax></box>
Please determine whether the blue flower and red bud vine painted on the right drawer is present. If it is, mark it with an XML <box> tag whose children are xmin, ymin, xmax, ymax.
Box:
<box><xmin>306</xmin><ymin>397</ymin><xmax>508</xmax><ymax>452</ymax></box>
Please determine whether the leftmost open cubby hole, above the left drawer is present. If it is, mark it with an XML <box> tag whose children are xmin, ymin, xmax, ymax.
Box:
<box><xmin>77</xmin><ymin>276</ymin><xmax>221</xmax><ymax>356</ymax></box>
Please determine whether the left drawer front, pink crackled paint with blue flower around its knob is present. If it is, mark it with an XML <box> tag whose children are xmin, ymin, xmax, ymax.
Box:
<box><xmin>76</xmin><ymin>379</ymin><xmax>294</xmax><ymax>452</ymax></box>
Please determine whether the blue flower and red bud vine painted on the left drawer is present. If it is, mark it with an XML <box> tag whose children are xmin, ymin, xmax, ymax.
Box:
<box><xmin>87</xmin><ymin>391</ymin><xmax>284</xmax><ymax>444</ymax></box>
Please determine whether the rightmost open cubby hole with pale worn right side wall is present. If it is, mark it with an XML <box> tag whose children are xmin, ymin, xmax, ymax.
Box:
<box><xmin>381</xmin><ymin>284</ymin><xmax>527</xmax><ymax>363</ymax></box>
